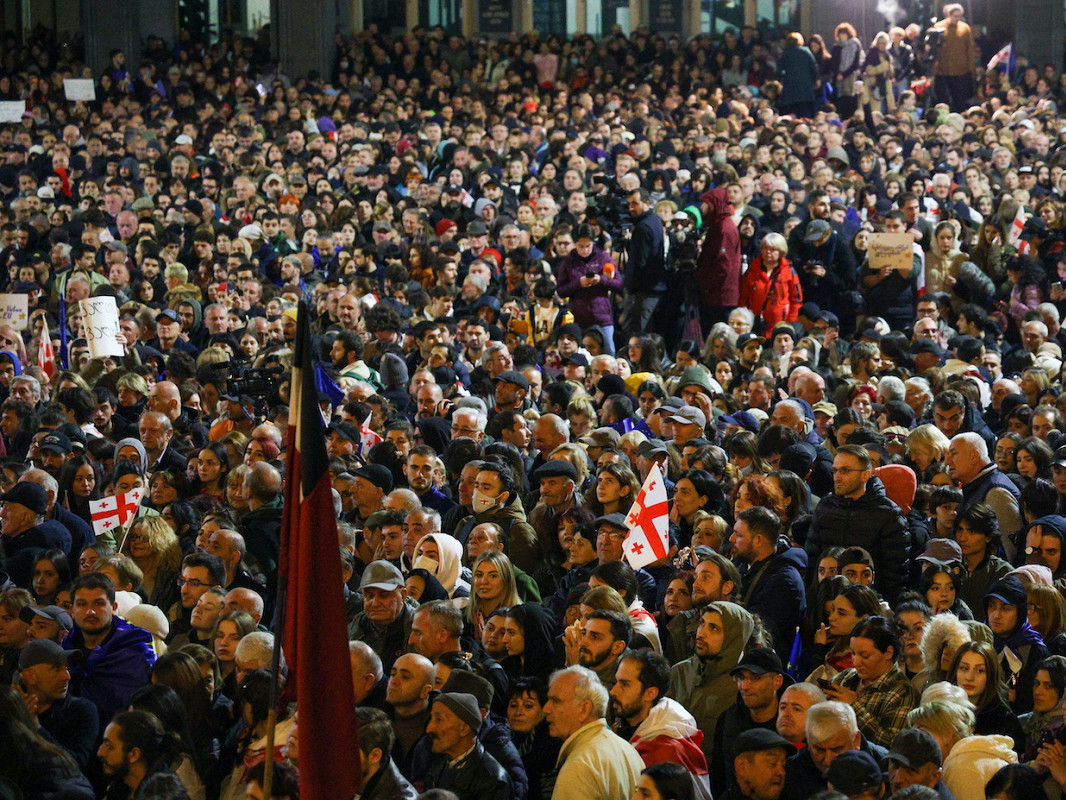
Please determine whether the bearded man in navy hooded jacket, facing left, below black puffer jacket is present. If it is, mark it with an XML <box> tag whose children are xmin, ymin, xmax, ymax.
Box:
<box><xmin>729</xmin><ymin>506</ymin><xmax>807</xmax><ymax>663</ymax></box>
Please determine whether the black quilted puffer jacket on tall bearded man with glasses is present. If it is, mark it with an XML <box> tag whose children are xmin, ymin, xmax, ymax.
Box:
<box><xmin>805</xmin><ymin>478</ymin><xmax>910</xmax><ymax>605</ymax></box>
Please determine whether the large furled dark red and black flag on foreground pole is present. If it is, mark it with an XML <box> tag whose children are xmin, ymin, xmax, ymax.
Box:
<box><xmin>278</xmin><ymin>303</ymin><xmax>361</xmax><ymax>800</ymax></box>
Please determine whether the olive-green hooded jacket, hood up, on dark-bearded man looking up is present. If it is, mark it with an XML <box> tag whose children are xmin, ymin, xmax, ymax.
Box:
<box><xmin>669</xmin><ymin>603</ymin><xmax>755</xmax><ymax>757</ymax></box>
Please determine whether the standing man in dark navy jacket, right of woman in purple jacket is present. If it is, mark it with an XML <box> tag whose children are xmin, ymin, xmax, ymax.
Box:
<box><xmin>623</xmin><ymin>189</ymin><xmax>667</xmax><ymax>334</ymax></box>
